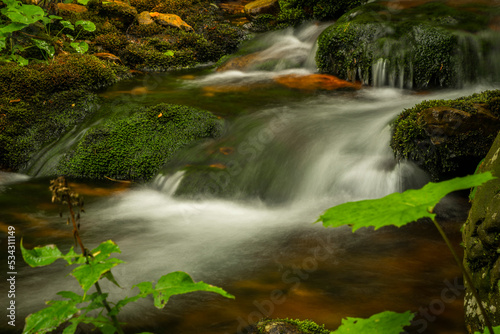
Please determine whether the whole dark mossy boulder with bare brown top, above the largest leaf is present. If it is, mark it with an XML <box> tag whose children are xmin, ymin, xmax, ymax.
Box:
<box><xmin>391</xmin><ymin>90</ymin><xmax>500</xmax><ymax>180</ymax></box>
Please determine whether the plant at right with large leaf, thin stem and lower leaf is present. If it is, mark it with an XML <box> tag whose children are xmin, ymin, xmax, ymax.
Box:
<box><xmin>317</xmin><ymin>172</ymin><xmax>500</xmax><ymax>334</ymax></box>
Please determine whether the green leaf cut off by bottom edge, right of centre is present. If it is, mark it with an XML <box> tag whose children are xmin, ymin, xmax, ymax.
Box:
<box><xmin>332</xmin><ymin>311</ymin><xmax>415</xmax><ymax>334</ymax></box>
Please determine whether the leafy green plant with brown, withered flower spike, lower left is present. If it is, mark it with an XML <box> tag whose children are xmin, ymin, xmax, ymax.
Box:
<box><xmin>21</xmin><ymin>177</ymin><xmax>234</xmax><ymax>334</ymax></box>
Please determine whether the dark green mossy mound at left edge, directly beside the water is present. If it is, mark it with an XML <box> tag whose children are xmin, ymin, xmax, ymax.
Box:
<box><xmin>0</xmin><ymin>90</ymin><xmax>97</xmax><ymax>171</ymax></box>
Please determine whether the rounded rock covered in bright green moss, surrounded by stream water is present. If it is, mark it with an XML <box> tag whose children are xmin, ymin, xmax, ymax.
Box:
<box><xmin>58</xmin><ymin>103</ymin><xmax>221</xmax><ymax>180</ymax></box>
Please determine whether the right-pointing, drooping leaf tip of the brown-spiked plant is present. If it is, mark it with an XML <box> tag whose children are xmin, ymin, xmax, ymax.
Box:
<box><xmin>153</xmin><ymin>271</ymin><xmax>234</xmax><ymax>308</ymax></box>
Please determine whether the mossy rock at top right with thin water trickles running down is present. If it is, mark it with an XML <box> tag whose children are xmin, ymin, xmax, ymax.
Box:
<box><xmin>316</xmin><ymin>2</ymin><xmax>500</xmax><ymax>89</ymax></box>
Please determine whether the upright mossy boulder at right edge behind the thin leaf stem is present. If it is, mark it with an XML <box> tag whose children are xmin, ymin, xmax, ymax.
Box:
<box><xmin>463</xmin><ymin>135</ymin><xmax>500</xmax><ymax>333</ymax></box>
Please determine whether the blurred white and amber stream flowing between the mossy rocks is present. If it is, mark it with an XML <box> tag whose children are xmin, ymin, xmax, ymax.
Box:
<box><xmin>0</xmin><ymin>25</ymin><xmax>500</xmax><ymax>334</ymax></box>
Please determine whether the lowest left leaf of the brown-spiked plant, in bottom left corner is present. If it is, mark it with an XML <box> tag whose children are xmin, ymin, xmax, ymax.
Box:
<box><xmin>23</xmin><ymin>300</ymin><xmax>78</xmax><ymax>334</ymax></box>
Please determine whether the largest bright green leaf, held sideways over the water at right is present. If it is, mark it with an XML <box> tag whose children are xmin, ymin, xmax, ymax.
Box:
<box><xmin>318</xmin><ymin>172</ymin><xmax>494</xmax><ymax>232</ymax></box>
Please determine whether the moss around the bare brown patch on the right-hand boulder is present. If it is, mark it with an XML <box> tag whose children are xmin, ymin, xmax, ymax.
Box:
<box><xmin>391</xmin><ymin>90</ymin><xmax>500</xmax><ymax>180</ymax></box>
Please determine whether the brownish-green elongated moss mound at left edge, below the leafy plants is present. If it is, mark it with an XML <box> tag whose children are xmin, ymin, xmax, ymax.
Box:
<box><xmin>0</xmin><ymin>54</ymin><xmax>129</xmax><ymax>101</ymax></box>
